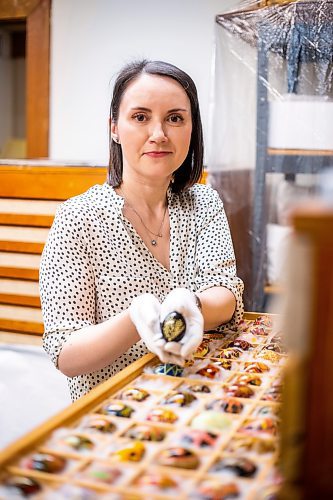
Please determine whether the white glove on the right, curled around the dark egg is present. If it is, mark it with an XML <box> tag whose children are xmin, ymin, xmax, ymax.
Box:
<box><xmin>160</xmin><ymin>288</ymin><xmax>204</xmax><ymax>360</ymax></box>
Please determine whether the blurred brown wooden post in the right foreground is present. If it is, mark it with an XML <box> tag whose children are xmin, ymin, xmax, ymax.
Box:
<box><xmin>281</xmin><ymin>206</ymin><xmax>333</xmax><ymax>500</ymax></box>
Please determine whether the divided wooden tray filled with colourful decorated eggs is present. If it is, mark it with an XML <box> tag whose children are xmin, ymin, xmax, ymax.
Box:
<box><xmin>0</xmin><ymin>313</ymin><xmax>287</xmax><ymax>500</ymax></box>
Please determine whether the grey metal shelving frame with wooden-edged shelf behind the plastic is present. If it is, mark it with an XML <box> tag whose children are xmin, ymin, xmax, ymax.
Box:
<box><xmin>252</xmin><ymin>1</ymin><xmax>333</xmax><ymax>311</ymax></box>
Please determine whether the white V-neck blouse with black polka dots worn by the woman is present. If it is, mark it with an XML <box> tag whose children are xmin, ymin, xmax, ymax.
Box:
<box><xmin>40</xmin><ymin>184</ymin><xmax>243</xmax><ymax>400</ymax></box>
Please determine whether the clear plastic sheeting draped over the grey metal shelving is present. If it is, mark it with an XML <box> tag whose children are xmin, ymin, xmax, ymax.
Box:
<box><xmin>208</xmin><ymin>0</ymin><xmax>333</xmax><ymax>311</ymax></box>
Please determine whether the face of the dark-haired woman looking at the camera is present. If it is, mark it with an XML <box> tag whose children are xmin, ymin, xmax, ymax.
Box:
<box><xmin>111</xmin><ymin>74</ymin><xmax>192</xmax><ymax>183</ymax></box>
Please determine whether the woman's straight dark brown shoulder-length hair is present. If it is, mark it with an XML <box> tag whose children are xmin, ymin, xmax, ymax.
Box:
<box><xmin>108</xmin><ymin>59</ymin><xmax>203</xmax><ymax>193</ymax></box>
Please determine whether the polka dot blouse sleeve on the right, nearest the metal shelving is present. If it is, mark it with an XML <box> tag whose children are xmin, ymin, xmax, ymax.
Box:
<box><xmin>195</xmin><ymin>190</ymin><xmax>244</xmax><ymax>332</ymax></box>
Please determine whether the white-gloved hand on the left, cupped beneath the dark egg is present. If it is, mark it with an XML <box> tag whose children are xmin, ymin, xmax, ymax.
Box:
<box><xmin>129</xmin><ymin>293</ymin><xmax>184</xmax><ymax>366</ymax></box>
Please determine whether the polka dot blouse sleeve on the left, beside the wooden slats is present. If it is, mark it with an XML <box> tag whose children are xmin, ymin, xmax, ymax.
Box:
<box><xmin>39</xmin><ymin>203</ymin><xmax>95</xmax><ymax>367</ymax></box>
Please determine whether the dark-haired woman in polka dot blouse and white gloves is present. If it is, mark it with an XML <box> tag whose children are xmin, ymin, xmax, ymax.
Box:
<box><xmin>40</xmin><ymin>60</ymin><xmax>243</xmax><ymax>399</ymax></box>
